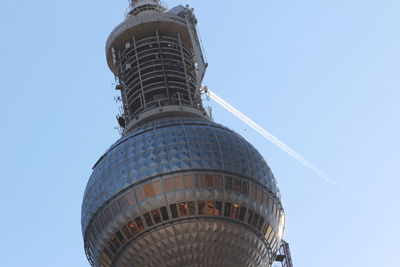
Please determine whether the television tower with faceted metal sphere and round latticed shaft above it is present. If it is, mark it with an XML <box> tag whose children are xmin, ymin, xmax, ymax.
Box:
<box><xmin>81</xmin><ymin>0</ymin><xmax>285</xmax><ymax>267</ymax></box>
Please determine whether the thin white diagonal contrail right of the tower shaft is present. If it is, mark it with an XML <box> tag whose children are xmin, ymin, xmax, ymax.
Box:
<box><xmin>207</xmin><ymin>89</ymin><xmax>356</xmax><ymax>199</ymax></box>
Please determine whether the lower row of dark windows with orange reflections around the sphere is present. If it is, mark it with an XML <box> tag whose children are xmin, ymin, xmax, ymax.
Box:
<box><xmin>97</xmin><ymin>200</ymin><xmax>279</xmax><ymax>267</ymax></box>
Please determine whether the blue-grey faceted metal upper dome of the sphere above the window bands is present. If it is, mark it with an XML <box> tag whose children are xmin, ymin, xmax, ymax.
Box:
<box><xmin>81</xmin><ymin>118</ymin><xmax>281</xmax><ymax>234</ymax></box>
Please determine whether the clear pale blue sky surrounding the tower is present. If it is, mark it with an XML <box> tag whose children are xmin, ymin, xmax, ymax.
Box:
<box><xmin>0</xmin><ymin>0</ymin><xmax>400</xmax><ymax>267</ymax></box>
